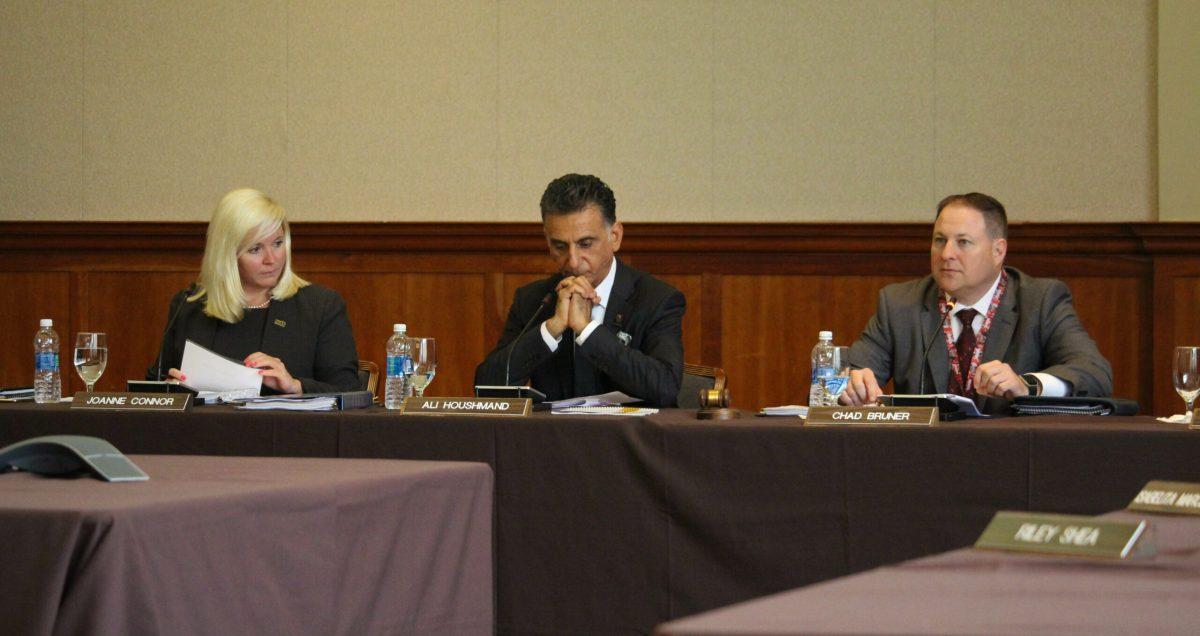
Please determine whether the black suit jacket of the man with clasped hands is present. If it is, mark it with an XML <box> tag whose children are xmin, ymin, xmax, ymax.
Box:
<box><xmin>475</xmin><ymin>259</ymin><xmax>685</xmax><ymax>407</ymax></box>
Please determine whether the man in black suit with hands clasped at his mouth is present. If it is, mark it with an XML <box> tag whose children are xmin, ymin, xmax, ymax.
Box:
<box><xmin>475</xmin><ymin>174</ymin><xmax>685</xmax><ymax>407</ymax></box>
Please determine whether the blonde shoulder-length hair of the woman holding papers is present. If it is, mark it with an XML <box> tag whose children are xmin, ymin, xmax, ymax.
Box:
<box><xmin>187</xmin><ymin>187</ymin><xmax>308</xmax><ymax>323</ymax></box>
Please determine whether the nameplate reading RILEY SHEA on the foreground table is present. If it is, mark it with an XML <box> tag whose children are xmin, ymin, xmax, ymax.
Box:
<box><xmin>974</xmin><ymin>510</ymin><xmax>1153</xmax><ymax>559</ymax></box>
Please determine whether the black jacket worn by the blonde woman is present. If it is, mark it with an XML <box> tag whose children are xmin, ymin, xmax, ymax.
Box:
<box><xmin>146</xmin><ymin>284</ymin><xmax>360</xmax><ymax>394</ymax></box>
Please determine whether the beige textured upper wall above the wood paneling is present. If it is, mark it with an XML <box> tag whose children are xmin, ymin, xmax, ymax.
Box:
<box><xmin>0</xmin><ymin>0</ymin><xmax>1158</xmax><ymax>222</ymax></box>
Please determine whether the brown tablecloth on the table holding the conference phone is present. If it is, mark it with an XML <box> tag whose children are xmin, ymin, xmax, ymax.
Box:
<box><xmin>0</xmin><ymin>456</ymin><xmax>493</xmax><ymax>635</ymax></box>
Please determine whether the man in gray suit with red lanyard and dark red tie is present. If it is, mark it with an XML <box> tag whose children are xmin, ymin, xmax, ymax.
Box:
<box><xmin>841</xmin><ymin>192</ymin><xmax>1112</xmax><ymax>414</ymax></box>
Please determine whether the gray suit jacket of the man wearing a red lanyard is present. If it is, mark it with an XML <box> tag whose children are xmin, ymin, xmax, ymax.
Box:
<box><xmin>850</xmin><ymin>268</ymin><xmax>1112</xmax><ymax>414</ymax></box>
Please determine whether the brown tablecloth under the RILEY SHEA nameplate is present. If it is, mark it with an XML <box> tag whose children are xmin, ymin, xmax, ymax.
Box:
<box><xmin>655</xmin><ymin>512</ymin><xmax>1200</xmax><ymax>636</ymax></box>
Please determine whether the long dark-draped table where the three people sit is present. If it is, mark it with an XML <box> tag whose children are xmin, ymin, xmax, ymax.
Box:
<box><xmin>0</xmin><ymin>404</ymin><xmax>1200</xmax><ymax>634</ymax></box>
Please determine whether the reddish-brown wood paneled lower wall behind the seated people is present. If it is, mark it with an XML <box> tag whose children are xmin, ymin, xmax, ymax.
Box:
<box><xmin>0</xmin><ymin>222</ymin><xmax>1200</xmax><ymax>414</ymax></box>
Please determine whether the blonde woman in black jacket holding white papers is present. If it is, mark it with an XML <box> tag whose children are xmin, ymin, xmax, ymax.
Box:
<box><xmin>146</xmin><ymin>188</ymin><xmax>359</xmax><ymax>394</ymax></box>
